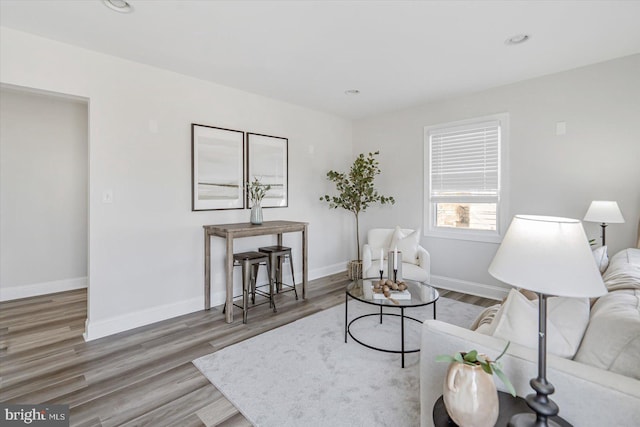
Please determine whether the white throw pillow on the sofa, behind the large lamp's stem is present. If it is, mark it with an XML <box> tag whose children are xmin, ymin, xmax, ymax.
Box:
<box><xmin>487</xmin><ymin>289</ymin><xmax>589</xmax><ymax>359</ymax></box>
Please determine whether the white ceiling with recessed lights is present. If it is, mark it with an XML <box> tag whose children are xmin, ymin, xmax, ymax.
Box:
<box><xmin>0</xmin><ymin>0</ymin><xmax>640</xmax><ymax>118</ymax></box>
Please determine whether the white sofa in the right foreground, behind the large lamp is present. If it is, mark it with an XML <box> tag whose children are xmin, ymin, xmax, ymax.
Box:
<box><xmin>420</xmin><ymin>249</ymin><xmax>640</xmax><ymax>427</ymax></box>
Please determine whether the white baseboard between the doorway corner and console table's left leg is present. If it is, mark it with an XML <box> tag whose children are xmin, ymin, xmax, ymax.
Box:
<box><xmin>83</xmin><ymin>297</ymin><xmax>204</xmax><ymax>341</ymax></box>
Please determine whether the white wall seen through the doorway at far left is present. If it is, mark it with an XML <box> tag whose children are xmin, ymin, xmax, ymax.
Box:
<box><xmin>0</xmin><ymin>89</ymin><xmax>88</xmax><ymax>300</ymax></box>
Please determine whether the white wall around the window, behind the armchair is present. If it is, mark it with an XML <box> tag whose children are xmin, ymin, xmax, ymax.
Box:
<box><xmin>353</xmin><ymin>55</ymin><xmax>640</xmax><ymax>297</ymax></box>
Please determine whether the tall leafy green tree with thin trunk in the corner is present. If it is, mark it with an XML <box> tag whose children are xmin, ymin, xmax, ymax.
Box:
<box><xmin>320</xmin><ymin>151</ymin><xmax>396</xmax><ymax>261</ymax></box>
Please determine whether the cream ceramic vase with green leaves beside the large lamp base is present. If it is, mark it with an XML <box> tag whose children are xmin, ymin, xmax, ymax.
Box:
<box><xmin>443</xmin><ymin>362</ymin><xmax>498</xmax><ymax>427</ymax></box>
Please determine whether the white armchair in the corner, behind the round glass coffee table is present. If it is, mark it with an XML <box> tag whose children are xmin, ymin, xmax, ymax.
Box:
<box><xmin>362</xmin><ymin>227</ymin><xmax>431</xmax><ymax>283</ymax></box>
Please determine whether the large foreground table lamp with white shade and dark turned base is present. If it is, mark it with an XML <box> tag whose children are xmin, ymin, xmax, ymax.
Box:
<box><xmin>489</xmin><ymin>215</ymin><xmax>607</xmax><ymax>426</ymax></box>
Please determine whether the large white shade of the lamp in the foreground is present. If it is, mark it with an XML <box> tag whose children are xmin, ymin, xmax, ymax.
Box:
<box><xmin>489</xmin><ymin>215</ymin><xmax>607</xmax><ymax>297</ymax></box>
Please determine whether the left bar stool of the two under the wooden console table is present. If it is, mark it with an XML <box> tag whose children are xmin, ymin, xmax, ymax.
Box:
<box><xmin>225</xmin><ymin>251</ymin><xmax>277</xmax><ymax>323</ymax></box>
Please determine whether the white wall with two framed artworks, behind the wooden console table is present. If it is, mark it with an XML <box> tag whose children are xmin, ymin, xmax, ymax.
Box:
<box><xmin>0</xmin><ymin>28</ymin><xmax>353</xmax><ymax>339</ymax></box>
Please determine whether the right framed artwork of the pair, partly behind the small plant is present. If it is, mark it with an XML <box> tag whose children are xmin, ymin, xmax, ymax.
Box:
<box><xmin>247</xmin><ymin>133</ymin><xmax>289</xmax><ymax>208</ymax></box>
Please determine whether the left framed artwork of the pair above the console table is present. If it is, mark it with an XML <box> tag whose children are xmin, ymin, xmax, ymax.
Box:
<box><xmin>191</xmin><ymin>123</ymin><xmax>244</xmax><ymax>211</ymax></box>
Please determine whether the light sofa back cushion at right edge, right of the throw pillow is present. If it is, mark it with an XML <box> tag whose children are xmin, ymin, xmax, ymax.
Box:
<box><xmin>574</xmin><ymin>289</ymin><xmax>640</xmax><ymax>379</ymax></box>
